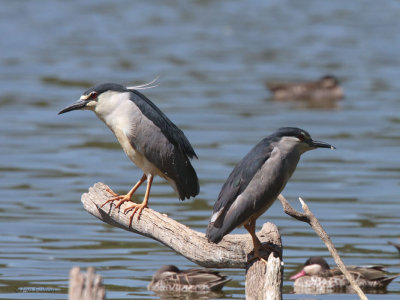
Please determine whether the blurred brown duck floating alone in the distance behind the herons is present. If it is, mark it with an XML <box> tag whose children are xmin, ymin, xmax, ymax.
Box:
<box><xmin>266</xmin><ymin>75</ymin><xmax>343</xmax><ymax>101</ymax></box>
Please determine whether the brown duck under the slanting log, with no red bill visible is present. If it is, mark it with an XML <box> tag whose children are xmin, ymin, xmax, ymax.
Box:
<box><xmin>147</xmin><ymin>265</ymin><xmax>230</xmax><ymax>292</ymax></box>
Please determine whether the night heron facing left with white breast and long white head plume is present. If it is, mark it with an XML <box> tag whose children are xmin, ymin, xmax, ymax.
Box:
<box><xmin>58</xmin><ymin>83</ymin><xmax>199</xmax><ymax>224</ymax></box>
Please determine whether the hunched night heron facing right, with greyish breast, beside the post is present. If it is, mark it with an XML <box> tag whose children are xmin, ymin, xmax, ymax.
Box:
<box><xmin>206</xmin><ymin>127</ymin><xmax>334</xmax><ymax>258</ymax></box>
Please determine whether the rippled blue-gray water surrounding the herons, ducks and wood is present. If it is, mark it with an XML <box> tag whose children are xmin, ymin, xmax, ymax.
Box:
<box><xmin>0</xmin><ymin>0</ymin><xmax>400</xmax><ymax>299</ymax></box>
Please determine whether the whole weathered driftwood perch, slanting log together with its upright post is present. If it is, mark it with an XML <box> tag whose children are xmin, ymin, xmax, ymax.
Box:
<box><xmin>81</xmin><ymin>183</ymin><xmax>283</xmax><ymax>299</ymax></box>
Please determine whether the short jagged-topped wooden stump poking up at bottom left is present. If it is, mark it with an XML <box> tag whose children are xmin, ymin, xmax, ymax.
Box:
<box><xmin>68</xmin><ymin>267</ymin><xmax>106</xmax><ymax>300</ymax></box>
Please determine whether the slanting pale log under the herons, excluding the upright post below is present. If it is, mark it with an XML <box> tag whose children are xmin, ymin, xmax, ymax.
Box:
<box><xmin>81</xmin><ymin>183</ymin><xmax>281</xmax><ymax>269</ymax></box>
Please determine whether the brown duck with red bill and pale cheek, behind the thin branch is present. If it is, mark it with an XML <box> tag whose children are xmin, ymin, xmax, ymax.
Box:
<box><xmin>290</xmin><ymin>256</ymin><xmax>400</xmax><ymax>294</ymax></box>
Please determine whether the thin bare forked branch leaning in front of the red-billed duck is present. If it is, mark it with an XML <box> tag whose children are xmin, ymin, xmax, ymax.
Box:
<box><xmin>278</xmin><ymin>194</ymin><xmax>368</xmax><ymax>300</ymax></box>
